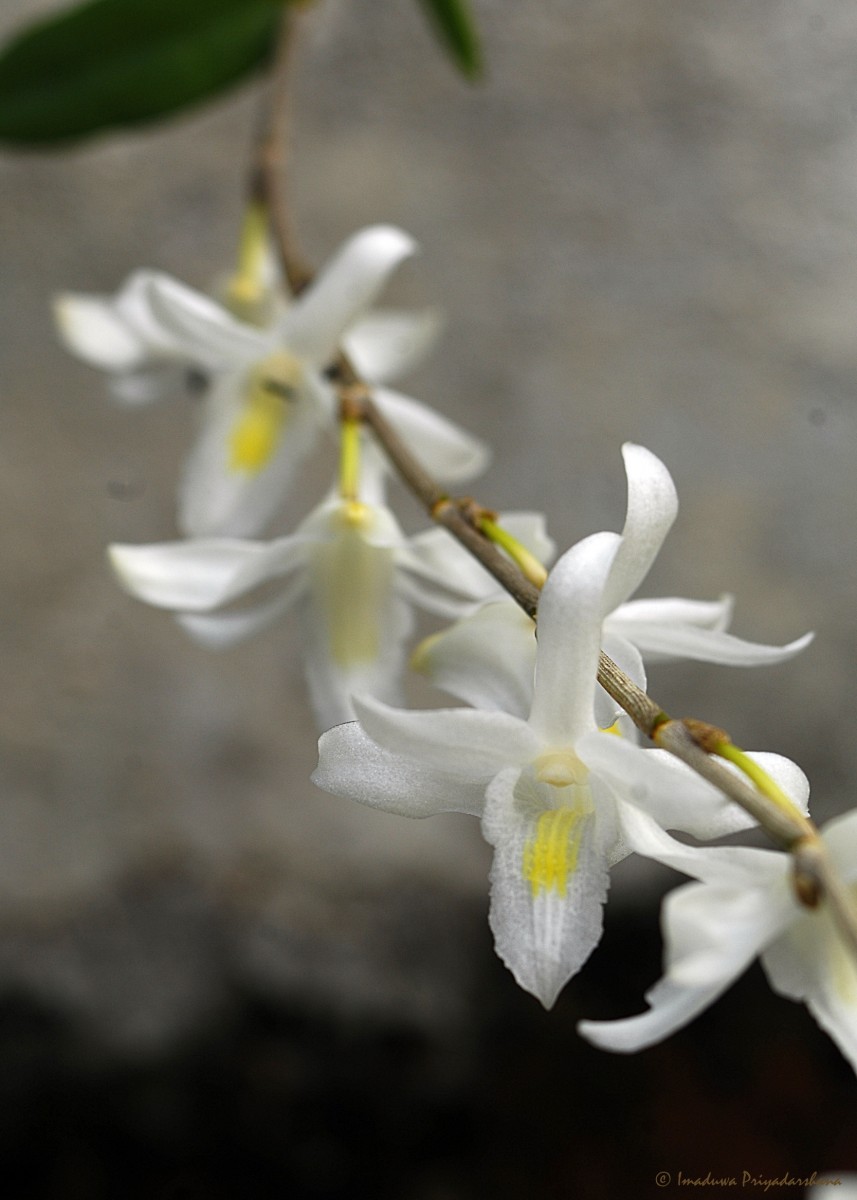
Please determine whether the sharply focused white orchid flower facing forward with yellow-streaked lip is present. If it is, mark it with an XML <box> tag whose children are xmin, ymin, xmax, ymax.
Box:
<box><xmin>313</xmin><ymin>533</ymin><xmax>801</xmax><ymax>1008</ymax></box>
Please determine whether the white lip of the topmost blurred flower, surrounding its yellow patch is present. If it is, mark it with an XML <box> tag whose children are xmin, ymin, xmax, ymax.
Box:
<box><xmin>178</xmin><ymin>372</ymin><xmax>318</xmax><ymax>538</ymax></box>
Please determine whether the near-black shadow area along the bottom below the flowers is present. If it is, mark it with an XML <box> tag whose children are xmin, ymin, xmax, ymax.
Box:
<box><xmin>0</xmin><ymin>908</ymin><xmax>857</xmax><ymax>1200</ymax></box>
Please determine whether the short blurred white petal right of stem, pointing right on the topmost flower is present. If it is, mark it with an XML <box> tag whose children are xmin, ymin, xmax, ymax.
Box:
<box><xmin>342</xmin><ymin>308</ymin><xmax>443</xmax><ymax>383</ymax></box>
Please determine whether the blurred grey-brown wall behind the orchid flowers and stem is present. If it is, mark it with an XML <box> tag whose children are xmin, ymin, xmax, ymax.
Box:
<box><xmin>0</xmin><ymin>0</ymin><xmax>857</xmax><ymax>1195</ymax></box>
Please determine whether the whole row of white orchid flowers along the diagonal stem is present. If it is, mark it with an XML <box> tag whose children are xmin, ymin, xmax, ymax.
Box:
<box><xmin>56</xmin><ymin>218</ymin><xmax>857</xmax><ymax>1068</ymax></box>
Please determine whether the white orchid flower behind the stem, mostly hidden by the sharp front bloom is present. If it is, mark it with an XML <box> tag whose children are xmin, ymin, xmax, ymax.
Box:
<box><xmin>416</xmin><ymin>443</ymin><xmax>813</xmax><ymax>725</ymax></box>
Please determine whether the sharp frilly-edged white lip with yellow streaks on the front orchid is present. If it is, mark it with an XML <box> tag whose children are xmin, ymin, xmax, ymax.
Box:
<box><xmin>483</xmin><ymin>769</ymin><xmax>609</xmax><ymax>1008</ymax></box>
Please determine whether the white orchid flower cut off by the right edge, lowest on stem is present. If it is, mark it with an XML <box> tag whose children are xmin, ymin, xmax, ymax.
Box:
<box><xmin>579</xmin><ymin>801</ymin><xmax>857</xmax><ymax>1070</ymax></box>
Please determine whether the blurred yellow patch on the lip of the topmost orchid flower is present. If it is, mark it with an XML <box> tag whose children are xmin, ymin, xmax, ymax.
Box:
<box><xmin>229</xmin><ymin>352</ymin><xmax>302</xmax><ymax>475</ymax></box>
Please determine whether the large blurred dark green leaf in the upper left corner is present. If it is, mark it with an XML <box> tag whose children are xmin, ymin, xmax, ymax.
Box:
<box><xmin>0</xmin><ymin>0</ymin><xmax>289</xmax><ymax>143</ymax></box>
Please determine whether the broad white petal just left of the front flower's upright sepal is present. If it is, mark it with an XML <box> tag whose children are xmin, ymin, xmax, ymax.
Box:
<box><xmin>410</xmin><ymin>600</ymin><xmax>535</xmax><ymax>720</ymax></box>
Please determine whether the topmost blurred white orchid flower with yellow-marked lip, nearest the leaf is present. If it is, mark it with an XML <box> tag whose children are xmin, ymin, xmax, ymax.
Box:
<box><xmin>56</xmin><ymin>226</ymin><xmax>487</xmax><ymax>536</ymax></box>
